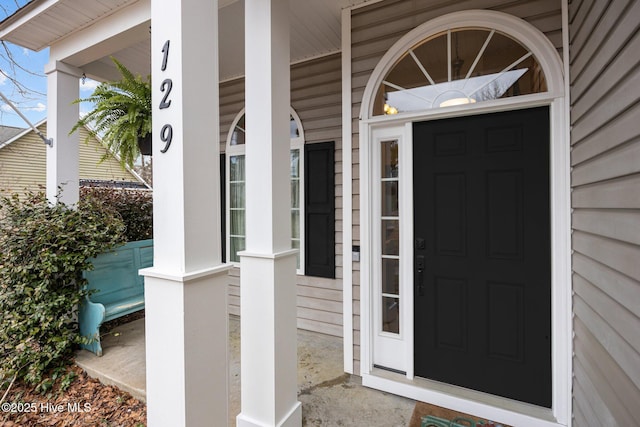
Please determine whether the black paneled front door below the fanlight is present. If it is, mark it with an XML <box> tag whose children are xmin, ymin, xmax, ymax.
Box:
<box><xmin>413</xmin><ymin>107</ymin><xmax>551</xmax><ymax>407</ymax></box>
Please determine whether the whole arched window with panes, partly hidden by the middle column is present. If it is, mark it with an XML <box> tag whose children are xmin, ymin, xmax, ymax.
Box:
<box><xmin>225</xmin><ymin>108</ymin><xmax>304</xmax><ymax>274</ymax></box>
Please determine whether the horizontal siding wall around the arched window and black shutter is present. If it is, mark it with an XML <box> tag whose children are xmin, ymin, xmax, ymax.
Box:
<box><xmin>220</xmin><ymin>54</ymin><xmax>343</xmax><ymax>336</ymax></box>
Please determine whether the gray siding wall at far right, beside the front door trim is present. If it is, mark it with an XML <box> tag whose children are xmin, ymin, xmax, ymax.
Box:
<box><xmin>569</xmin><ymin>0</ymin><xmax>640</xmax><ymax>427</ymax></box>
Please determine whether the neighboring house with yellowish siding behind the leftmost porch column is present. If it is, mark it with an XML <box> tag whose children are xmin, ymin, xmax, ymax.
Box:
<box><xmin>0</xmin><ymin>120</ymin><xmax>150</xmax><ymax>193</ymax></box>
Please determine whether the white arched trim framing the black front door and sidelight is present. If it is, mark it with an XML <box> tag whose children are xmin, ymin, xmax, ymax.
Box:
<box><xmin>360</xmin><ymin>11</ymin><xmax>572</xmax><ymax>426</ymax></box>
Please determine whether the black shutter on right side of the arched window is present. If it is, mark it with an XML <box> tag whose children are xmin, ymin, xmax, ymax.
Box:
<box><xmin>304</xmin><ymin>142</ymin><xmax>336</xmax><ymax>279</ymax></box>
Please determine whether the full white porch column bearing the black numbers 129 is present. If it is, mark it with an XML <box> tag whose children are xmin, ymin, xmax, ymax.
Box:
<box><xmin>142</xmin><ymin>0</ymin><xmax>228</xmax><ymax>427</ymax></box>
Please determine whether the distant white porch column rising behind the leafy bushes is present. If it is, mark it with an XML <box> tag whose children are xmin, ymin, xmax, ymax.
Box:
<box><xmin>45</xmin><ymin>61</ymin><xmax>82</xmax><ymax>205</ymax></box>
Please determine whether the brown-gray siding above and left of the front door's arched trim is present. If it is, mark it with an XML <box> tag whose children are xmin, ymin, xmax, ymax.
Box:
<box><xmin>351</xmin><ymin>0</ymin><xmax>562</xmax><ymax>373</ymax></box>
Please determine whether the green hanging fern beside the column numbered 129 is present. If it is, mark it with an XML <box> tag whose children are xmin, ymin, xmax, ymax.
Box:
<box><xmin>70</xmin><ymin>57</ymin><xmax>151</xmax><ymax>167</ymax></box>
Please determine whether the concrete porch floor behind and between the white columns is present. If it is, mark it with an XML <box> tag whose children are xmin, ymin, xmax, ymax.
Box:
<box><xmin>76</xmin><ymin>316</ymin><xmax>415</xmax><ymax>427</ymax></box>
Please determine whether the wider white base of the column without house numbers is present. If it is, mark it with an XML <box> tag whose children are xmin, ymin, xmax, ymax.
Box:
<box><xmin>237</xmin><ymin>250</ymin><xmax>302</xmax><ymax>427</ymax></box>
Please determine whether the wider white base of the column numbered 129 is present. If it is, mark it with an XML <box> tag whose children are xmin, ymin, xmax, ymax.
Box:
<box><xmin>140</xmin><ymin>265</ymin><xmax>231</xmax><ymax>427</ymax></box>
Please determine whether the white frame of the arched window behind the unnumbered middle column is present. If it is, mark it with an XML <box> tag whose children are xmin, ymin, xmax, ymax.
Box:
<box><xmin>224</xmin><ymin>108</ymin><xmax>305</xmax><ymax>275</ymax></box>
